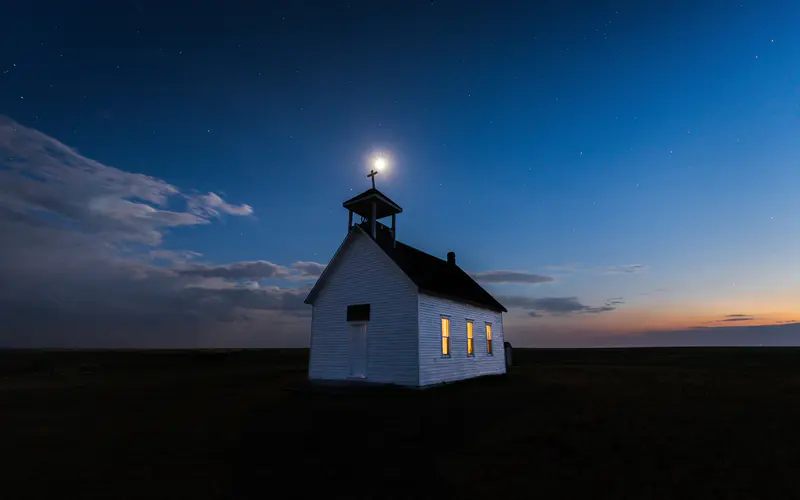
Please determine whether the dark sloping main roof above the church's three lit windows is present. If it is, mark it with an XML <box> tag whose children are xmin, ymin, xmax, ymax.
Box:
<box><xmin>362</xmin><ymin>222</ymin><xmax>507</xmax><ymax>312</ymax></box>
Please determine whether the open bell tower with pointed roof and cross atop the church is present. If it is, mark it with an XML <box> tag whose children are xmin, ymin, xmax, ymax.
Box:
<box><xmin>342</xmin><ymin>170</ymin><xmax>403</xmax><ymax>246</ymax></box>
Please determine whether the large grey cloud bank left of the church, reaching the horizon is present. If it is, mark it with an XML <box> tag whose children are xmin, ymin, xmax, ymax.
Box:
<box><xmin>0</xmin><ymin>117</ymin><xmax>312</xmax><ymax>347</ymax></box>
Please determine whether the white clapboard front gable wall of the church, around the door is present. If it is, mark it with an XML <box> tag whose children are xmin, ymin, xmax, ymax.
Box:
<box><xmin>309</xmin><ymin>230</ymin><xmax>418</xmax><ymax>386</ymax></box>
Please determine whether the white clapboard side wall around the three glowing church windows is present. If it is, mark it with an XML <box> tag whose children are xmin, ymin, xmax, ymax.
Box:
<box><xmin>419</xmin><ymin>294</ymin><xmax>506</xmax><ymax>386</ymax></box>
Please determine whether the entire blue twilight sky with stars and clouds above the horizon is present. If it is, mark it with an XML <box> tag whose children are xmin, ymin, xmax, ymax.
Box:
<box><xmin>0</xmin><ymin>0</ymin><xmax>800</xmax><ymax>347</ymax></box>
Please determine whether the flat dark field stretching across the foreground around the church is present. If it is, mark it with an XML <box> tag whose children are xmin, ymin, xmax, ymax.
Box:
<box><xmin>0</xmin><ymin>348</ymin><xmax>800</xmax><ymax>500</ymax></box>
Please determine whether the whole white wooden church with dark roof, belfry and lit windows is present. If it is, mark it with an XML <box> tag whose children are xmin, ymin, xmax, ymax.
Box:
<box><xmin>305</xmin><ymin>177</ymin><xmax>506</xmax><ymax>387</ymax></box>
